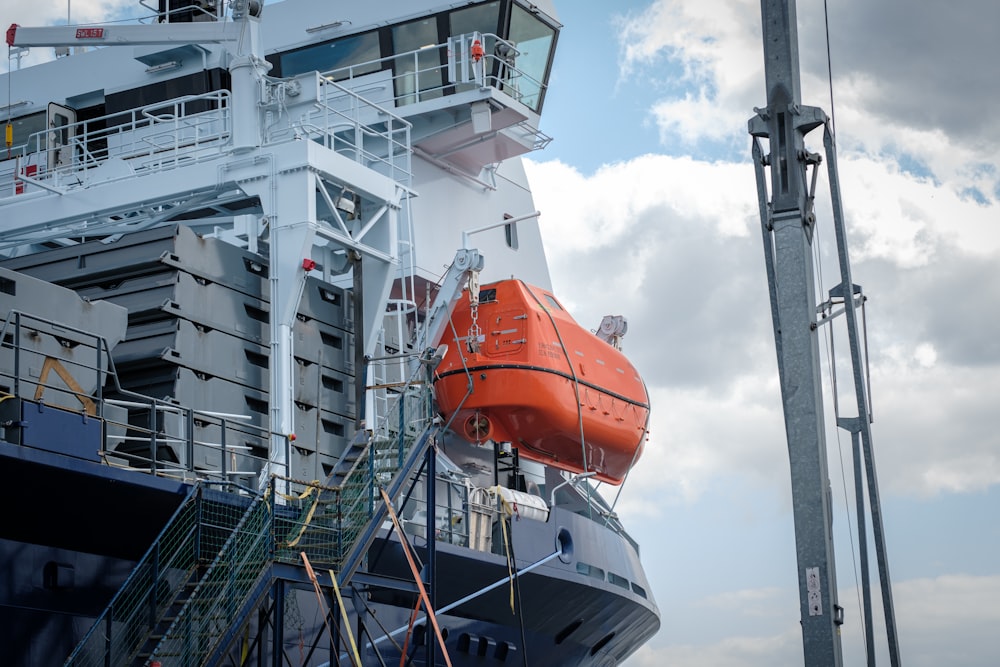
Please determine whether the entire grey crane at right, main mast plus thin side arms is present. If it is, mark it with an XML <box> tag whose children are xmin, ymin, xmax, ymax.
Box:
<box><xmin>749</xmin><ymin>0</ymin><xmax>899</xmax><ymax>667</ymax></box>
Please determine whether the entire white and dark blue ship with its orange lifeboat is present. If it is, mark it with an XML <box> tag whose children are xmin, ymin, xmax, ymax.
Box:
<box><xmin>0</xmin><ymin>0</ymin><xmax>660</xmax><ymax>667</ymax></box>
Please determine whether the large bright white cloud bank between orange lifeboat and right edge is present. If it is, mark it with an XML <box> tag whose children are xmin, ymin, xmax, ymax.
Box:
<box><xmin>528</xmin><ymin>154</ymin><xmax>1000</xmax><ymax>500</ymax></box>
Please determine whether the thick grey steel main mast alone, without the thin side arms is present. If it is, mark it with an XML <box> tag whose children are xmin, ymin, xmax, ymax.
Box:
<box><xmin>749</xmin><ymin>0</ymin><xmax>843</xmax><ymax>667</ymax></box>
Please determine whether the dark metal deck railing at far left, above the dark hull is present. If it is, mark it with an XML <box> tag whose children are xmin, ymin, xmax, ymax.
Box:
<box><xmin>0</xmin><ymin>309</ymin><xmax>271</xmax><ymax>486</ymax></box>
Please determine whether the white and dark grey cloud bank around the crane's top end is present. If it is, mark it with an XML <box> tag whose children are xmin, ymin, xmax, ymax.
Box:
<box><xmin>621</xmin><ymin>0</ymin><xmax>1000</xmax><ymax>209</ymax></box>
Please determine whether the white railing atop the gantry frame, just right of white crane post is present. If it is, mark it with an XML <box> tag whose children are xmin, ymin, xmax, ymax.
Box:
<box><xmin>264</xmin><ymin>73</ymin><xmax>412</xmax><ymax>185</ymax></box>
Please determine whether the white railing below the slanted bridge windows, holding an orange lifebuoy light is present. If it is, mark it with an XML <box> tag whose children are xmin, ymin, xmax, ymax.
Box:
<box><xmin>324</xmin><ymin>33</ymin><xmax>546</xmax><ymax>111</ymax></box>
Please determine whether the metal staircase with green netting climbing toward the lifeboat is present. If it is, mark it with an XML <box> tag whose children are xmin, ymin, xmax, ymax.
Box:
<box><xmin>65</xmin><ymin>378</ymin><xmax>438</xmax><ymax>667</ymax></box>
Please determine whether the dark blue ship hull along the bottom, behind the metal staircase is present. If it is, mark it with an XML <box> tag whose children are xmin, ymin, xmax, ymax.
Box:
<box><xmin>0</xmin><ymin>442</ymin><xmax>659</xmax><ymax>667</ymax></box>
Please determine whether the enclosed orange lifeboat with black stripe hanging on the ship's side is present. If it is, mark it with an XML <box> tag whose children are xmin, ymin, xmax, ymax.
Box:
<box><xmin>434</xmin><ymin>280</ymin><xmax>649</xmax><ymax>484</ymax></box>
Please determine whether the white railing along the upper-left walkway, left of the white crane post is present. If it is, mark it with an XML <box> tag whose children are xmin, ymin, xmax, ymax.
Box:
<box><xmin>0</xmin><ymin>90</ymin><xmax>231</xmax><ymax>197</ymax></box>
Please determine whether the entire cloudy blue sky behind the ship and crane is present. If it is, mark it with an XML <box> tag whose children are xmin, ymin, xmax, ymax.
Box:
<box><xmin>0</xmin><ymin>0</ymin><xmax>1000</xmax><ymax>667</ymax></box>
